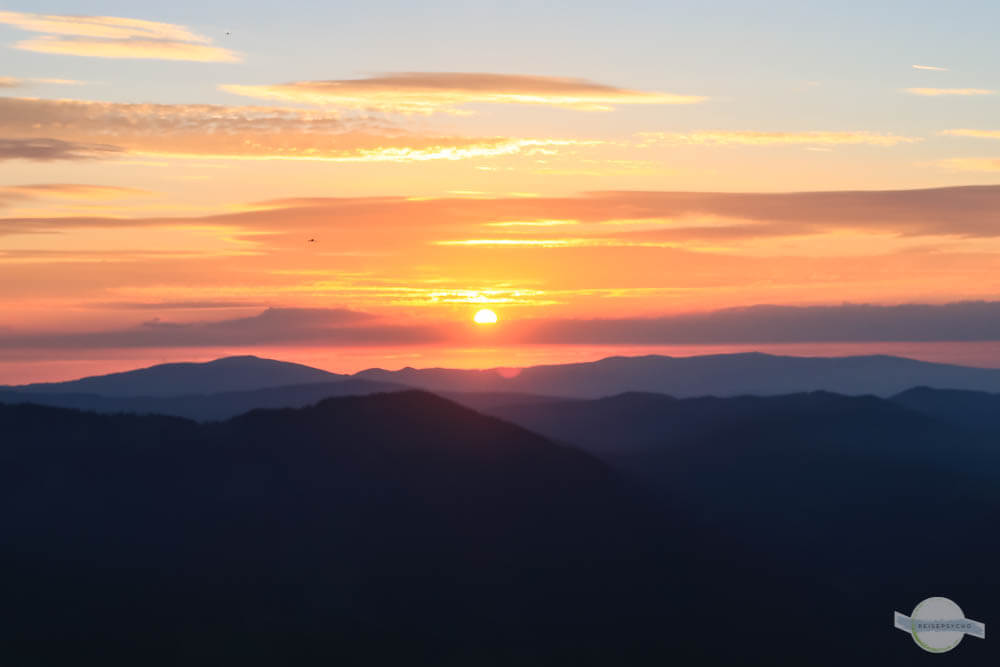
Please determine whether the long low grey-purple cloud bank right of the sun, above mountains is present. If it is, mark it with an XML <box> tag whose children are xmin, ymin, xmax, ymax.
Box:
<box><xmin>506</xmin><ymin>301</ymin><xmax>1000</xmax><ymax>345</ymax></box>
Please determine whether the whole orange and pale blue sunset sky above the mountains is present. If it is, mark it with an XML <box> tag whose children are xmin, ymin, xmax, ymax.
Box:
<box><xmin>0</xmin><ymin>0</ymin><xmax>1000</xmax><ymax>384</ymax></box>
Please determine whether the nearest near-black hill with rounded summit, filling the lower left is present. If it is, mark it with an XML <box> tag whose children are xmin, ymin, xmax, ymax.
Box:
<box><xmin>0</xmin><ymin>392</ymin><xmax>692</xmax><ymax>665</ymax></box>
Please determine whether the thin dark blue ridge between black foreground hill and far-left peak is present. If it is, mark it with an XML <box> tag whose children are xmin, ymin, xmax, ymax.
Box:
<box><xmin>0</xmin><ymin>379</ymin><xmax>408</xmax><ymax>421</ymax></box>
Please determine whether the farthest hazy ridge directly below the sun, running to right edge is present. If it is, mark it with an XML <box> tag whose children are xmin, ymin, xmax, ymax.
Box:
<box><xmin>356</xmin><ymin>353</ymin><xmax>1000</xmax><ymax>398</ymax></box>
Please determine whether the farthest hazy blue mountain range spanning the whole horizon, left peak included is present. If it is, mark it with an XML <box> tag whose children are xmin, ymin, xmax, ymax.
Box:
<box><xmin>9</xmin><ymin>352</ymin><xmax>1000</xmax><ymax>398</ymax></box>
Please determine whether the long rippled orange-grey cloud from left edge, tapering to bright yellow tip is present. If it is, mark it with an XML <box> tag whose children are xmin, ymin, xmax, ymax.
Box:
<box><xmin>0</xmin><ymin>97</ymin><xmax>584</xmax><ymax>162</ymax></box>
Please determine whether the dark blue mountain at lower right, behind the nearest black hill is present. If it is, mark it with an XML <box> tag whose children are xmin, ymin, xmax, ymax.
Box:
<box><xmin>476</xmin><ymin>392</ymin><xmax>1000</xmax><ymax>665</ymax></box>
